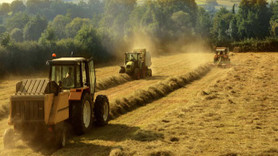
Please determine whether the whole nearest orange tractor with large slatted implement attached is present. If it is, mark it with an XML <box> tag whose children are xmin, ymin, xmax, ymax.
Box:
<box><xmin>3</xmin><ymin>57</ymin><xmax>109</xmax><ymax>148</ymax></box>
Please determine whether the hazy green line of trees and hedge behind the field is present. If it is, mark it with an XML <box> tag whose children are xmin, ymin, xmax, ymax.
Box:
<box><xmin>0</xmin><ymin>0</ymin><xmax>278</xmax><ymax>75</ymax></box>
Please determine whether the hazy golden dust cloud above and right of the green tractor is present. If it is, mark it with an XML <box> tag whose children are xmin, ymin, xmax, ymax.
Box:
<box><xmin>127</xmin><ymin>32</ymin><xmax>212</xmax><ymax>68</ymax></box>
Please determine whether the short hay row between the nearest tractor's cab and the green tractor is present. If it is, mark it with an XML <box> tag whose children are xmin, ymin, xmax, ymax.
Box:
<box><xmin>96</xmin><ymin>74</ymin><xmax>132</xmax><ymax>91</ymax></box>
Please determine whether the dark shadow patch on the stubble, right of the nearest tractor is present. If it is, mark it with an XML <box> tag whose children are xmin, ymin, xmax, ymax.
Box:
<box><xmin>80</xmin><ymin>124</ymin><xmax>164</xmax><ymax>142</ymax></box>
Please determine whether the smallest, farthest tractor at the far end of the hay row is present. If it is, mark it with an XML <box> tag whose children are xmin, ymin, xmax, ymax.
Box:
<box><xmin>214</xmin><ymin>47</ymin><xmax>230</xmax><ymax>67</ymax></box>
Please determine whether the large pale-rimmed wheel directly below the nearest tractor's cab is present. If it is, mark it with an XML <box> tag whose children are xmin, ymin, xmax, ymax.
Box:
<box><xmin>71</xmin><ymin>94</ymin><xmax>93</xmax><ymax>135</ymax></box>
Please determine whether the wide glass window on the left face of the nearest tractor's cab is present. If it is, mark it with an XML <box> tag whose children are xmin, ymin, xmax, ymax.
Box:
<box><xmin>50</xmin><ymin>65</ymin><xmax>80</xmax><ymax>89</ymax></box>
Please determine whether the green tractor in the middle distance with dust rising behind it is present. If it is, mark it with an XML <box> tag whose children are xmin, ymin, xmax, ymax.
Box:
<box><xmin>119</xmin><ymin>49</ymin><xmax>152</xmax><ymax>80</ymax></box>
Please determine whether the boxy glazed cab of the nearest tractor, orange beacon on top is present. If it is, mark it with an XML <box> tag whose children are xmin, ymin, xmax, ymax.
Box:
<box><xmin>48</xmin><ymin>57</ymin><xmax>96</xmax><ymax>94</ymax></box>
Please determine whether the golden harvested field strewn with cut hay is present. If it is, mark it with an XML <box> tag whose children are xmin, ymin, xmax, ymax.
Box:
<box><xmin>0</xmin><ymin>53</ymin><xmax>278</xmax><ymax>156</ymax></box>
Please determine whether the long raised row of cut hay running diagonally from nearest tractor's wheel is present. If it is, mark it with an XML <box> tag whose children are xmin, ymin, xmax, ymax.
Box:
<box><xmin>110</xmin><ymin>64</ymin><xmax>211</xmax><ymax>119</ymax></box>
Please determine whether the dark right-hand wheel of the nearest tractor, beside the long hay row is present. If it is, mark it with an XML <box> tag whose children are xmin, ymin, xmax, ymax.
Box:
<box><xmin>94</xmin><ymin>95</ymin><xmax>110</xmax><ymax>126</ymax></box>
